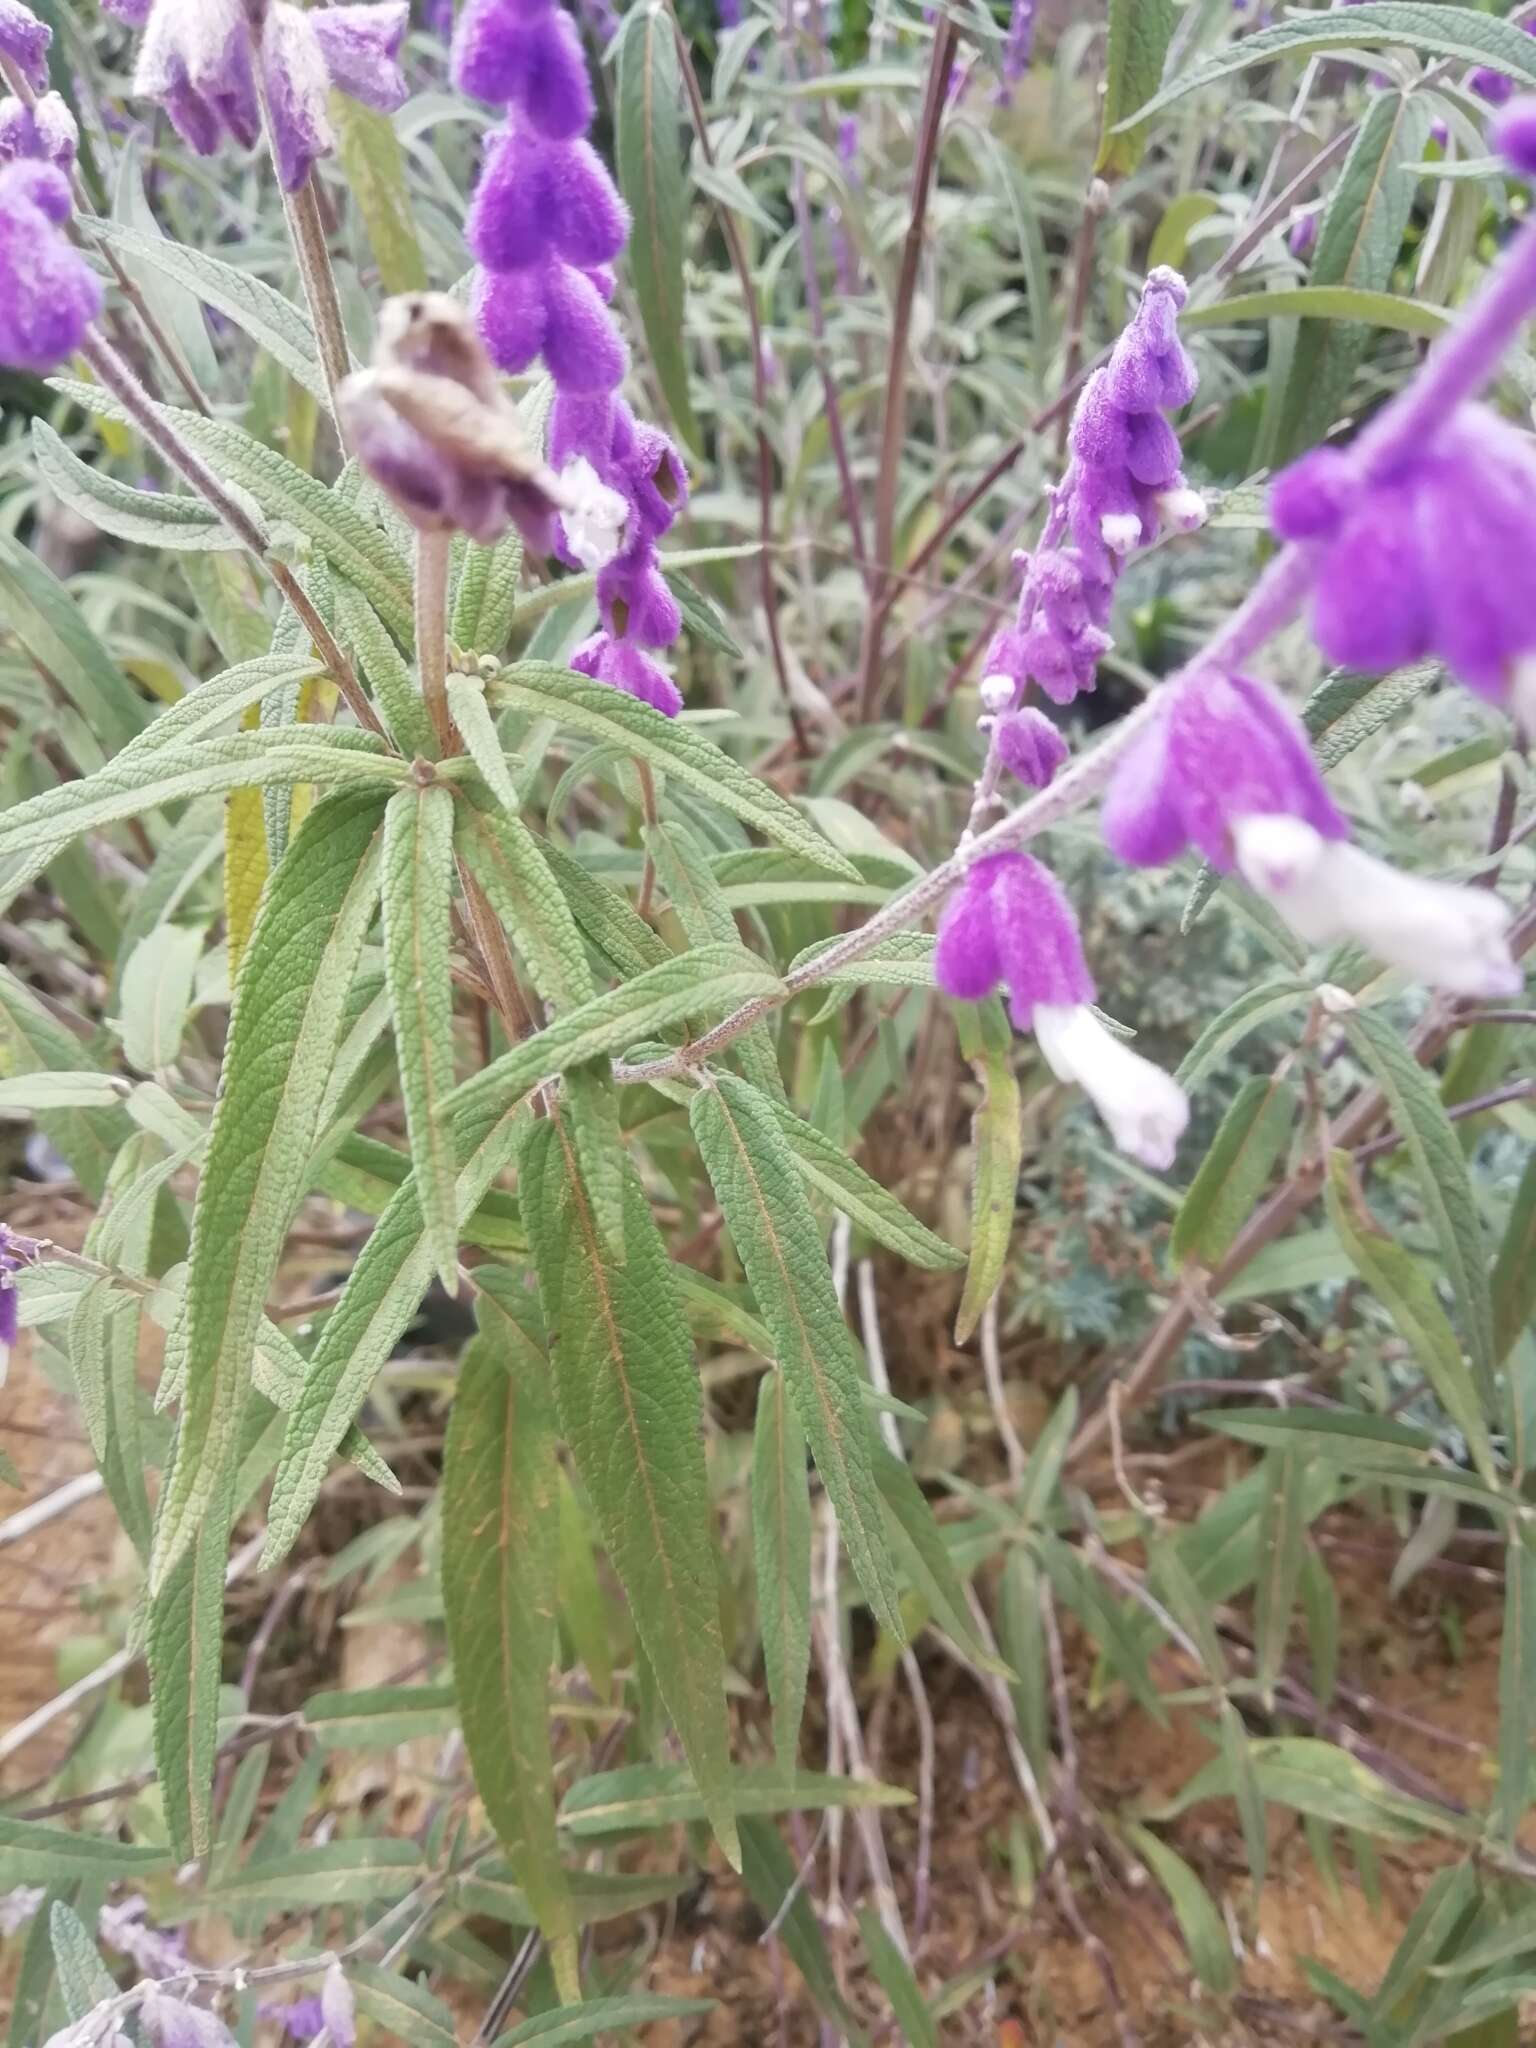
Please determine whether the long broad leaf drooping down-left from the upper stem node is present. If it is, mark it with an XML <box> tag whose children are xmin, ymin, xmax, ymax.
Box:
<box><xmin>152</xmin><ymin>791</ymin><xmax>379</xmax><ymax>1587</ymax></box>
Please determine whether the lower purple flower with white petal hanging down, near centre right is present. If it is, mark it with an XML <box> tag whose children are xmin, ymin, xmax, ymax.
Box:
<box><xmin>934</xmin><ymin>854</ymin><xmax>1190</xmax><ymax>1169</ymax></box>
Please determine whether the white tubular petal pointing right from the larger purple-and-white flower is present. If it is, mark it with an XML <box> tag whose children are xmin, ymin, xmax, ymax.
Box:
<box><xmin>1233</xmin><ymin>817</ymin><xmax>1524</xmax><ymax>997</ymax></box>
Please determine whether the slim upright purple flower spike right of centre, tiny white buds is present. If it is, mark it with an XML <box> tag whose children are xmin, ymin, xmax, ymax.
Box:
<box><xmin>983</xmin><ymin>266</ymin><xmax>1206</xmax><ymax>745</ymax></box>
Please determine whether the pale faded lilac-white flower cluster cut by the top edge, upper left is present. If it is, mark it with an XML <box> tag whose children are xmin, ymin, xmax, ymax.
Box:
<box><xmin>123</xmin><ymin>0</ymin><xmax>410</xmax><ymax>193</ymax></box>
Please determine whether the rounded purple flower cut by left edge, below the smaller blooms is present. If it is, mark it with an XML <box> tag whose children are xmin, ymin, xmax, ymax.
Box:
<box><xmin>0</xmin><ymin>158</ymin><xmax>102</xmax><ymax>375</ymax></box>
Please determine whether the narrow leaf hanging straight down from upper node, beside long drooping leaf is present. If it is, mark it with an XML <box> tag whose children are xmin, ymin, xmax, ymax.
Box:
<box><xmin>383</xmin><ymin>782</ymin><xmax>459</xmax><ymax>1294</ymax></box>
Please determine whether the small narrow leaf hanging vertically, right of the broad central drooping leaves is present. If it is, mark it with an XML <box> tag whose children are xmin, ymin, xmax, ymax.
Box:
<box><xmin>743</xmin><ymin>1372</ymin><xmax>811</xmax><ymax>1769</ymax></box>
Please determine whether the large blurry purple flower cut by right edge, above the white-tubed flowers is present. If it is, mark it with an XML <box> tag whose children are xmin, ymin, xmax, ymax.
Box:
<box><xmin>1270</xmin><ymin>406</ymin><xmax>1536</xmax><ymax>709</ymax></box>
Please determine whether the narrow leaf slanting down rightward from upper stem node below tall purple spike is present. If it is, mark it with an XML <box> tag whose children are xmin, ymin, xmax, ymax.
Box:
<box><xmin>492</xmin><ymin>662</ymin><xmax>860</xmax><ymax>883</ymax></box>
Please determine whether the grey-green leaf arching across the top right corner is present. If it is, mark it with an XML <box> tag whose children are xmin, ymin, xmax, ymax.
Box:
<box><xmin>1122</xmin><ymin>0</ymin><xmax>1536</xmax><ymax>125</ymax></box>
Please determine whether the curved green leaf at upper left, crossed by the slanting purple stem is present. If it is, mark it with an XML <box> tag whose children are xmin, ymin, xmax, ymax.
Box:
<box><xmin>49</xmin><ymin>377</ymin><xmax>412</xmax><ymax>647</ymax></box>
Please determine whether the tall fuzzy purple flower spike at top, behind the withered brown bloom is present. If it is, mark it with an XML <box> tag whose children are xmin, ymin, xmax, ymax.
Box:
<box><xmin>453</xmin><ymin>0</ymin><xmax>688</xmax><ymax>717</ymax></box>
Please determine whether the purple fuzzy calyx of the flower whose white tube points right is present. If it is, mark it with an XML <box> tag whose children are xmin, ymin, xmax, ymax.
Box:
<box><xmin>1104</xmin><ymin>670</ymin><xmax>1350</xmax><ymax>872</ymax></box>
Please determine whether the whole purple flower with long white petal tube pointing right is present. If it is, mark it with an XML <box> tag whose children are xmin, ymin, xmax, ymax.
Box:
<box><xmin>1104</xmin><ymin>670</ymin><xmax>1522</xmax><ymax>997</ymax></box>
